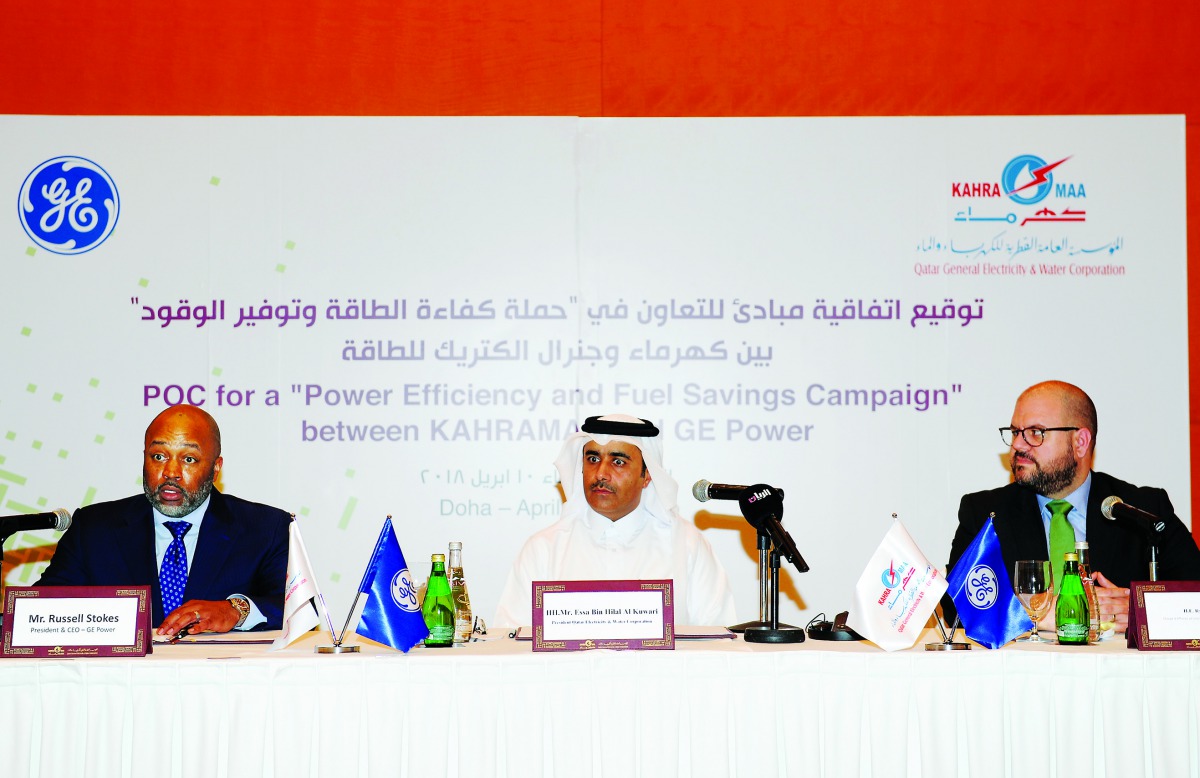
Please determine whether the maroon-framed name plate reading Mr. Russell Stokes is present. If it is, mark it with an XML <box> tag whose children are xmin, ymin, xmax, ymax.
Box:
<box><xmin>0</xmin><ymin>586</ymin><xmax>152</xmax><ymax>658</ymax></box>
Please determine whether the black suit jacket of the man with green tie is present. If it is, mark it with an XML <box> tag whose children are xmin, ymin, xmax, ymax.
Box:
<box><xmin>942</xmin><ymin>472</ymin><xmax>1200</xmax><ymax>618</ymax></box>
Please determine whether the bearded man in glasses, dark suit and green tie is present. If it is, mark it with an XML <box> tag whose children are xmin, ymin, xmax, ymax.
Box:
<box><xmin>943</xmin><ymin>381</ymin><xmax>1200</xmax><ymax>632</ymax></box>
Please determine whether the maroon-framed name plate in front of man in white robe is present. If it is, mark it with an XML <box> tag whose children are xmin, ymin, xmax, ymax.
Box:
<box><xmin>533</xmin><ymin>580</ymin><xmax>674</xmax><ymax>651</ymax></box>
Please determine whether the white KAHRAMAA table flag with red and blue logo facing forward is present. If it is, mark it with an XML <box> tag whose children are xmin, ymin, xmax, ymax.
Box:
<box><xmin>846</xmin><ymin>521</ymin><xmax>946</xmax><ymax>651</ymax></box>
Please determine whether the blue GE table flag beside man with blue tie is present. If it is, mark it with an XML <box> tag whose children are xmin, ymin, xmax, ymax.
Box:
<box><xmin>354</xmin><ymin>516</ymin><xmax>430</xmax><ymax>652</ymax></box>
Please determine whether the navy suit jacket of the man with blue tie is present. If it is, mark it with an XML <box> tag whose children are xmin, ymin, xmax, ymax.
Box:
<box><xmin>36</xmin><ymin>490</ymin><xmax>292</xmax><ymax>629</ymax></box>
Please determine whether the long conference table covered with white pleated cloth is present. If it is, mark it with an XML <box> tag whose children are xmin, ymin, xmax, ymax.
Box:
<box><xmin>0</xmin><ymin>633</ymin><xmax>1200</xmax><ymax>778</ymax></box>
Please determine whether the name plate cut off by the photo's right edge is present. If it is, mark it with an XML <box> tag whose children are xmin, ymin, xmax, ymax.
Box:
<box><xmin>1126</xmin><ymin>581</ymin><xmax>1200</xmax><ymax>651</ymax></box>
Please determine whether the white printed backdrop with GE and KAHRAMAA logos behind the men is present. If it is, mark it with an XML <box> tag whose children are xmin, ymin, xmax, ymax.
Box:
<box><xmin>0</xmin><ymin>116</ymin><xmax>1190</xmax><ymax>623</ymax></box>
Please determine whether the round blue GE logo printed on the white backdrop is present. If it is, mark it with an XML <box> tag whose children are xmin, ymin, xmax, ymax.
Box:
<box><xmin>17</xmin><ymin>156</ymin><xmax>121</xmax><ymax>255</ymax></box>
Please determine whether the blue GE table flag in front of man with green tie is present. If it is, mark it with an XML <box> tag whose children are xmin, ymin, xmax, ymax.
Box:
<box><xmin>946</xmin><ymin>516</ymin><xmax>1033</xmax><ymax>648</ymax></box>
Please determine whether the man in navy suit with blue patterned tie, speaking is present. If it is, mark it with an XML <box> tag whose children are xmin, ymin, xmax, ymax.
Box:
<box><xmin>37</xmin><ymin>406</ymin><xmax>290</xmax><ymax>635</ymax></box>
